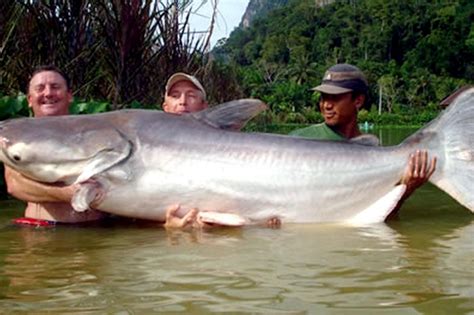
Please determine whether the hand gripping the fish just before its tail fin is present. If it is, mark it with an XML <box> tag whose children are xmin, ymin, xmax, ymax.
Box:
<box><xmin>400</xmin><ymin>150</ymin><xmax>436</xmax><ymax>198</ymax></box>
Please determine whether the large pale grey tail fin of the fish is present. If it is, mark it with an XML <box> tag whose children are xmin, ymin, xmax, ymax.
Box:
<box><xmin>406</xmin><ymin>88</ymin><xmax>474</xmax><ymax>212</ymax></box>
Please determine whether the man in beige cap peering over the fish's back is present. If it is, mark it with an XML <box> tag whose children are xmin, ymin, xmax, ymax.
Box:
<box><xmin>163</xmin><ymin>72</ymin><xmax>208</xmax><ymax>115</ymax></box>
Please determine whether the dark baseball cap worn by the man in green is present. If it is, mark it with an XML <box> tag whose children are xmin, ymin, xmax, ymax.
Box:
<box><xmin>312</xmin><ymin>63</ymin><xmax>368</xmax><ymax>94</ymax></box>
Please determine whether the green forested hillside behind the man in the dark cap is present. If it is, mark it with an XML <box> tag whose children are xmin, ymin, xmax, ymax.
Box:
<box><xmin>216</xmin><ymin>0</ymin><xmax>474</xmax><ymax>124</ymax></box>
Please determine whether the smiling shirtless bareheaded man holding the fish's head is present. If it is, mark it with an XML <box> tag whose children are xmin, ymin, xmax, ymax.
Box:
<box><xmin>5</xmin><ymin>66</ymin><xmax>104</xmax><ymax>226</ymax></box>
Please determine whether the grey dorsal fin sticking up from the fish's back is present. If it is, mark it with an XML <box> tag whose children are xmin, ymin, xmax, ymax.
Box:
<box><xmin>191</xmin><ymin>98</ymin><xmax>267</xmax><ymax>131</ymax></box>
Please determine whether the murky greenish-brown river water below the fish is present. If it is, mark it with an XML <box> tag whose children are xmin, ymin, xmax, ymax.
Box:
<box><xmin>0</xmin><ymin>131</ymin><xmax>474</xmax><ymax>314</ymax></box>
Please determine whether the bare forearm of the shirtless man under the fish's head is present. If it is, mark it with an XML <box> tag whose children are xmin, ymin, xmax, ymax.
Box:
<box><xmin>5</xmin><ymin>166</ymin><xmax>75</xmax><ymax>203</ymax></box>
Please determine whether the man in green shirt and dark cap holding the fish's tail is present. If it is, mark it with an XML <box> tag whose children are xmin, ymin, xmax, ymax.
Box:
<box><xmin>290</xmin><ymin>64</ymin><xmax>436</xmax><ymax>218</ymax></box>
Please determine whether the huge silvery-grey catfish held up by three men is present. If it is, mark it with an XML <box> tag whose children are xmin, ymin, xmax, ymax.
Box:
<box><xmin>0</xmin><ymin>89</ymin><xmax>474</xmax><ymax>224</ymax></box>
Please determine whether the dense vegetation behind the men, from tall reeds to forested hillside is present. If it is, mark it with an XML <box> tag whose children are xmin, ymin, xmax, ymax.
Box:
<box><xmin>0</xmin><ymin>0</ymin><xmax>474</xmax><ymax>124</ymax></box>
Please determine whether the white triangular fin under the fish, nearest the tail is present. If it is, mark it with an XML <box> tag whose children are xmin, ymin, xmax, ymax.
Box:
<box><xmin>347</xmin><ymin>185</ymin><xmax>406</xmax><ymax>225</ymax></box>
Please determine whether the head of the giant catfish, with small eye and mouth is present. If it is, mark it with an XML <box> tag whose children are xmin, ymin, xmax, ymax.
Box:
<box><xmin>0</xmin><ymin>116</ymin><xmax>130</xmax><ymax>184</ymax></box>
